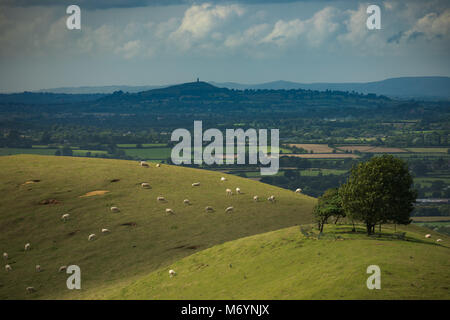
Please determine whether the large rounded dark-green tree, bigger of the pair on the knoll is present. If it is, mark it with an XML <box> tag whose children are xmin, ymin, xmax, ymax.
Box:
<box><xmin>339</xmin><ymin>155</ymin><xmax>417</xmax><ymax>235</ymax></box>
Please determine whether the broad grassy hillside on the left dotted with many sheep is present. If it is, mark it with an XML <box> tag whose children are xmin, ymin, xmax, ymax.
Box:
<box><xmin>0</xmin><ymin>155</ymin><xmax>315</xmax><ymax>299</ymax></box>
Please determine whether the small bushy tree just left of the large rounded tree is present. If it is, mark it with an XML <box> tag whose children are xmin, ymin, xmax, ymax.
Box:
<box><xmin>313</xmin><ymin>188</ymin><xmax>345</xmax><ymax>232</ymax></box>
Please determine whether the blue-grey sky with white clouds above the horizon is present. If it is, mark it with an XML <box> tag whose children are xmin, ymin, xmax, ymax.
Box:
<box><xmin>0</xmin><ymin>0</ymin><xmax>450</xmax><ymax>92</ymax></box>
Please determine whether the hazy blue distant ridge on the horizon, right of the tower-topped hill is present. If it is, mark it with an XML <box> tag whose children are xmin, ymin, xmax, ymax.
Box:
<box><xmin>211</xmin><ymin>77</ymin><xmax>450</xmax><ymax>99</ymax></box>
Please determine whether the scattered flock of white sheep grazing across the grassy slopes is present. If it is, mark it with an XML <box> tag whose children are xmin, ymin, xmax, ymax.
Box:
<box><xmin>3</xmin><ymin>161</ymin><xmax>302</xmax><ymax>293</ymax></box>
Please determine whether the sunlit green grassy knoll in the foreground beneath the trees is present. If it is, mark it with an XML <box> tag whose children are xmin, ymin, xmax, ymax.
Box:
<box><xmin>104</xmin><ymin>222</ymin><xmax>450</xmax><ymax>299</ymax></box>
